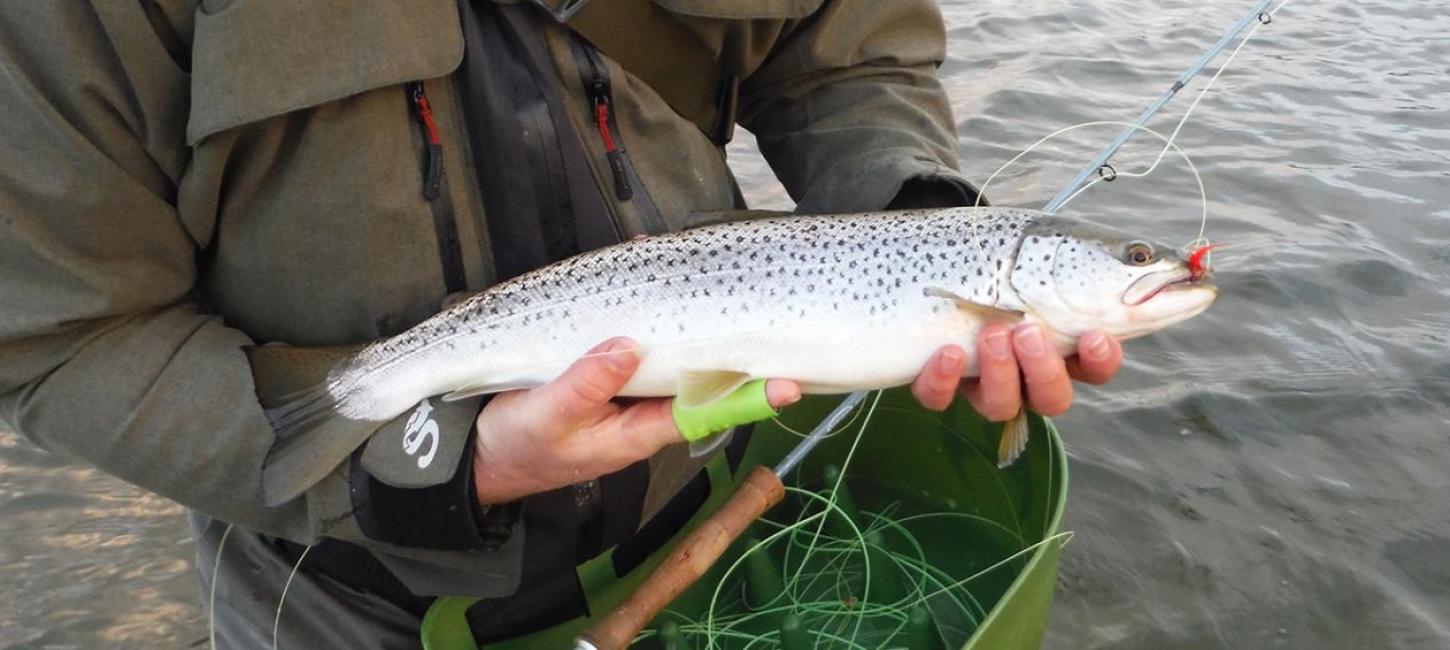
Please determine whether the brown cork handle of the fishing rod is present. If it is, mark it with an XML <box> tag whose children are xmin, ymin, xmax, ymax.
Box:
<box><xmin>579</xmin><ymin>467</ymin><xmax>786</xmax><ymax>650</ymax></box>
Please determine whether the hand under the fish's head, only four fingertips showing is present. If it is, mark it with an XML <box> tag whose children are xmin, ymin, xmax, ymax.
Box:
<box><xmin>912</xmin><ymin>324</ymin><xmax>1122</xmax><ymax>422</ymax></box>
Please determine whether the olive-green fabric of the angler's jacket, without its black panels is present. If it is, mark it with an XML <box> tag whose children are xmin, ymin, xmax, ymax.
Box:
<box><xmin>0</xmin><ymin>0</ymin><xmax>974</xmax><ymax>592</ymax></box>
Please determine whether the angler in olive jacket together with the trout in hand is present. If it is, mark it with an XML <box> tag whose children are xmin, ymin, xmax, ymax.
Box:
<box><xmin>0</xmin><ymin>0</ymin><xmax>1136</xmax><ymax>647</ymax></box>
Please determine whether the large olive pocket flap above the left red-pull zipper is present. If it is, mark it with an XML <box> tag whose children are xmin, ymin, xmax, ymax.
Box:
<box><xmin>187</xmin><ymin>0</ymin><xmax>463</xmax><ymax>145</ymax></box>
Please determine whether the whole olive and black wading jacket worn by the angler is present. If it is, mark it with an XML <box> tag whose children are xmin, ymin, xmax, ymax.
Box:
<box><xmin>0</xmin><ymin>0</ymin><xmax>969</xmax><ymax>596</ymax></box>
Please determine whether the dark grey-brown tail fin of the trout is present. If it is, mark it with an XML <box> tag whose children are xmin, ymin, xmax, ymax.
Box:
<box><xmin>245</xmin><ymin>345</ymin><xmax>383</xmax><ymax>508</ymax></box>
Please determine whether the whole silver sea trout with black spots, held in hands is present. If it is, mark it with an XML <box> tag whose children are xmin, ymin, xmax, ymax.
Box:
<box><xmin>249</xmin><ymin>207</ymin><xmax>1218</xmax><ymax>505</ymax></box>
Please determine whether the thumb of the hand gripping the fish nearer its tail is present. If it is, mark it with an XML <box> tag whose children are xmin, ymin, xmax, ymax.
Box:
<box><xmin>529</xmin><ymin>338</ymin><xmax>639</xmax><ymax>425</ymax></box>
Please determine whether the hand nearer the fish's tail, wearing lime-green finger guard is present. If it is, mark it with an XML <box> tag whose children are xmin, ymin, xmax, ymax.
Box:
<box><xmin>473</xmin><ymin>338</ymin><xmax>800</xmax><ymax>505</ymax></box>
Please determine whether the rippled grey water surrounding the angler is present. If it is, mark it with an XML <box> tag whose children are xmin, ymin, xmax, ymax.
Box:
<box><xmin>0</xmin><ymin>0</ymin><xmax>1450</xmax><ymax>649</ymax></box>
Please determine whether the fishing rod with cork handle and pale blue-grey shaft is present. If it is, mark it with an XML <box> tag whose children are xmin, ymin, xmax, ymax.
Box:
<box><xmin>574</xmin><ymin>0</ymin><xmax>1273</xmax><ymax>650</ymax></box>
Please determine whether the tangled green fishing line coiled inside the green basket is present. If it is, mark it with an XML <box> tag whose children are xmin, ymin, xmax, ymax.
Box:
<box><xmin>637</xmin><ymin>395</ymin><xmax>1070</xmax><ymax>650</ymax></box>
